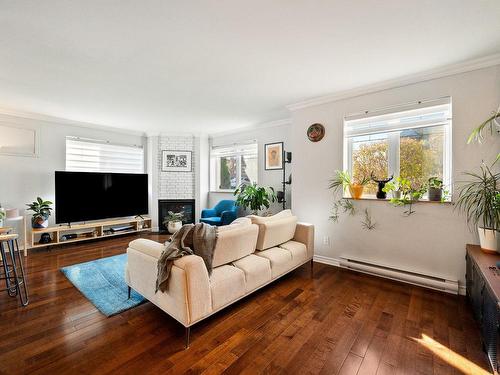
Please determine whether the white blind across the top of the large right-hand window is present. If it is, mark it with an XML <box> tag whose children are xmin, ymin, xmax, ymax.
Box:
<box><xmin>344</xmin><ymin>98</ymin><xmax>451</xmax><ymax>137</ymax></box>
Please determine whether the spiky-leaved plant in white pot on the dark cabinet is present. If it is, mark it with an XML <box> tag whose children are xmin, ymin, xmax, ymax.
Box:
<box><xmin>456</xmin><ymin>163</ymin><xmax>500</xmax><ymax>252</ymax></box>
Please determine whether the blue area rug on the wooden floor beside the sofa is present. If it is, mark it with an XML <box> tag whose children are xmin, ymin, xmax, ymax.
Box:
<box><xmin>61</xmin><ymin>254</ymin><xmax>145</xmax><ymax>316</ymax></box>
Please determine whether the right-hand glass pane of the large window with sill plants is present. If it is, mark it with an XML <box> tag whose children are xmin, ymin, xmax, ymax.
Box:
<box><xmin>399</xmin><ymin>126</ymin><xmax>445</xmax><ymax>188</ymax></box>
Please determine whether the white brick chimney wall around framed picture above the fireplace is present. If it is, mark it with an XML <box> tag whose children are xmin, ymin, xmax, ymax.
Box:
<box><xmin>157</xmin><ymin>136</ymin><xmax>197</xmax><ymax>199</ymax></box>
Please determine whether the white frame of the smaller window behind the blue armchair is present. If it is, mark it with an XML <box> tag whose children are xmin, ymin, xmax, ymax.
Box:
<box><xmin>210</xmin><ymin>141</ymin><xmax>259</xmax><ymax>193</ymax></box>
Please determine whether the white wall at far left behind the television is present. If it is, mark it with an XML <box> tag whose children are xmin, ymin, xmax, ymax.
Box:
<box><xmin>0</xmin><ymin>115</ymin><xmax>146</xmax><ymax>241</ymax></box>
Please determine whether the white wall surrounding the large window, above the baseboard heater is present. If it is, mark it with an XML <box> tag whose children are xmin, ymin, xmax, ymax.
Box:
<box><xmin>292</xmin><ymin>66</ymin><xmax>500</xmax><ymax>288</ymax></box>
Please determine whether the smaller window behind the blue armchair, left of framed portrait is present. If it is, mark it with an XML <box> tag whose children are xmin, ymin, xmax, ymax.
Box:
<box><xmin>210</xmin><ymin>142</ymin><xmax>258</xmax><ymax>191</ymax></box>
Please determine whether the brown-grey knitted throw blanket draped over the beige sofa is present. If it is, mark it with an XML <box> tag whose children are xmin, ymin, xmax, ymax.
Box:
<box><xmin>156</xmin><ymin>223</ymin><xmax>217</xmax><ymax>292</ymax></box>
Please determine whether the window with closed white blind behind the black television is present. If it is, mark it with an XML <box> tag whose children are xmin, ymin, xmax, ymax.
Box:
<box><xmin>66</xmin><ymin>137</ymin><xmax>144</xmax><ymax>173</ymax></box>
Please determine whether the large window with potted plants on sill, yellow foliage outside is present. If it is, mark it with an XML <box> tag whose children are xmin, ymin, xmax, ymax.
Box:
<box><xmin>344</xmin><ymin>98</ymin><xmax>451</xmax><ymax>200</ymax></box>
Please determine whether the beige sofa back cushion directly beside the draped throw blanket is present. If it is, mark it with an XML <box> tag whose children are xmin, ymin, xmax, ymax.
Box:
<box><xmin>212</xmin><ymin>220</ymin><xmax>259</xmax><ymax>267</ymax></box>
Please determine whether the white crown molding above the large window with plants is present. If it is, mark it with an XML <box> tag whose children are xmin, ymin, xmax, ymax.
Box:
<box><xmin>286</xmin><ymin>53</ymin><xmax>500</xmax><ymax>111</ymax></box>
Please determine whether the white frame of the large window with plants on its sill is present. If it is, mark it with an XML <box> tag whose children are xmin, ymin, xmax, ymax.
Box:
<box><xmin>343</xmin><ymin>97</ymin><xmax>453</xmax><ymax>202</ymax></box>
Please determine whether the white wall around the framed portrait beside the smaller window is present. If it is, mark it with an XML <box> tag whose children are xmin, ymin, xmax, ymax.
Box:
<box><xmin>208</xmin><ymin>124</ymin><xmax>293</xmax><ymax>212</ymax></box>
